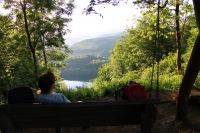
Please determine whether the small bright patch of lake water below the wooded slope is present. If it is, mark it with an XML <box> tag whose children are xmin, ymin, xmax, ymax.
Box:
<box><xmin>64</xmin><ymin>80</ymin><xmax>91</xmax><ymax>89</ymax></box>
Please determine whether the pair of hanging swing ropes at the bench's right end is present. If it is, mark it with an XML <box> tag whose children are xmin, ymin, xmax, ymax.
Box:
<box><xmin>149</xmin><ymin>0</ymin><xmax>168</xmax><ymax>99</ymax></box>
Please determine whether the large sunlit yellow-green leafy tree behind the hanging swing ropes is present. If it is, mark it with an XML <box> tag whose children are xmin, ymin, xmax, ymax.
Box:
<box><xmin>110</xmin><ymin>6</ymin><xmax>176</xmax><ymax>78</ymax></box>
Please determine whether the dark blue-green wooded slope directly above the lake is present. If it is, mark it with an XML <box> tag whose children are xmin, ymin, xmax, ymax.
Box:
<box><xmin>61</xmin><ymin>55</ymin><xmax>108</xmax><ymax>81</ymax></box>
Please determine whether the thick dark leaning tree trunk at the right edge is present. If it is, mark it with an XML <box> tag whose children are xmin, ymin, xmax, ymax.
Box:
<box><xmin>176</xmin><ymin>0</ymin><xmax>200</xmax><ymax>122</ymax></box>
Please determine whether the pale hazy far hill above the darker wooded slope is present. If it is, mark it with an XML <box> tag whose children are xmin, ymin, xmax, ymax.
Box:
<box><xmin>69</xmin><ymin>32</ymin><xmax>124</xmax><ymax>57</ymax></box>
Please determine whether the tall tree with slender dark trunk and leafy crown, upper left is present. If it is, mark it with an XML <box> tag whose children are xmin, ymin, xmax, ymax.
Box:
<box><xmin>2</xmin><ymin>0</ymin><xmax>74</xmax><ymax>84</ymax></box>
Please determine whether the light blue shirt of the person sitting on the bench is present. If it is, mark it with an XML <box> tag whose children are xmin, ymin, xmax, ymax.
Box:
<box><xmin>35</xmin><ymin>92</ymin><xmax>70</xmax><ymax>103</ymax></box>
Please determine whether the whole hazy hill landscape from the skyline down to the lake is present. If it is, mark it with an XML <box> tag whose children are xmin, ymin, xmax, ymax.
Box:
<box><xmin>61</xmin><ymin>32</ymin><xmax>125</xmax><ymax>81</ymax></box>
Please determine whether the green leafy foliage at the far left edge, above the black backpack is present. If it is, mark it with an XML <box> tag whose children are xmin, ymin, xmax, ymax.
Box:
<box><xmin>0</xmin><ymin>15</ymin><xmax>17</xmax><ymax>89</ymax></box>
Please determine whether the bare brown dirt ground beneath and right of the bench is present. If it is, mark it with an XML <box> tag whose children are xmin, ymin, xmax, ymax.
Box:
<box><xmin>31</xmin><ymin>89</ymin><xmax>200</xmax><ymax>133</ymax></box>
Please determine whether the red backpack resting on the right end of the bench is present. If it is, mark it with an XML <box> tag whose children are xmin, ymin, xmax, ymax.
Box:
<box><xmin>124</xmin><ymin>83</ymin><xmax>147</xmax><ymax>100</ymax></box>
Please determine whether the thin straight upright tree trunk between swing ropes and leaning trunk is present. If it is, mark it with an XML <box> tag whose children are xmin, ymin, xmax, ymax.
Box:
<box><xmin>175</xmin><ymin>0</ymin><xmax>181</xmax><ymax>74</ymax></box>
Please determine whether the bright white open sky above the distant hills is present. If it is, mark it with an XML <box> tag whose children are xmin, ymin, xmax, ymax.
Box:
<box><xmin>66</xmin><ymin>0</ymin><xmax>140</xmax><ymax>42</ymax></box>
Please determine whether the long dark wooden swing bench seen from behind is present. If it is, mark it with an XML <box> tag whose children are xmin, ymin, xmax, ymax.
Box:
<box><xmin>0</xmin><ymin>99</ymin><xmax>160</xmax><ymax>133</ymax></box>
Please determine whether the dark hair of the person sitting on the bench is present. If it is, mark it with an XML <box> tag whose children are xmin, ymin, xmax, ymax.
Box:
<box><xmin>38</xmin><ymin>72</ymin><xmax>56</xmax><ymax>93</ymax></box>
